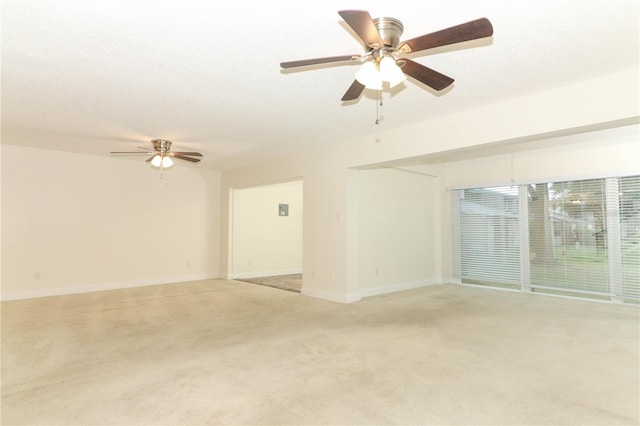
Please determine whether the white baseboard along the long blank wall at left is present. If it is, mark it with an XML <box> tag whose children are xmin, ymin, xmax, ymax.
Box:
<box><xmin>0</xmin><ymin>274</ymin><xmax>220</xmax><ymax>302</ymax></box>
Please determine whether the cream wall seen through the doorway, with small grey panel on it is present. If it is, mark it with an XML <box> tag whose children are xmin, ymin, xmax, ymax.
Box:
<box><xmin>230</xmin><ymin>181</ymin><xmax>303</xmax><ymax>278</ymax></box>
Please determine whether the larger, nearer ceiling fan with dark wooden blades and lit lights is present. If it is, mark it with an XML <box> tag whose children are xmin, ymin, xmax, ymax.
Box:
<box><xmin>280</xmin><ymin>10</ymin><xmax>493</xmax><ymax>101</ymax></box>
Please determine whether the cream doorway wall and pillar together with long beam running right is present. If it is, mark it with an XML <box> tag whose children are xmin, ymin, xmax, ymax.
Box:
<box><xmin>221</xmin><ymin>69</ymin><xmax>640</xmax><ymax>302</ymax></box>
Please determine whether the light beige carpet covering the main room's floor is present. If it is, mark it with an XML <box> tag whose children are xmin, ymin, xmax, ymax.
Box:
<box><xmin>1</xmin><ymin>280</ymin><xmax>640</xmax><ymax>425</ymax></box>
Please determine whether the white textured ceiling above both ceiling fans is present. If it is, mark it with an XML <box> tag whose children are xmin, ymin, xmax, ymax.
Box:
<box><xmin>1</xmin><ymin>0</ymin><xmax>640</xmax><ymax>169</ymax></box>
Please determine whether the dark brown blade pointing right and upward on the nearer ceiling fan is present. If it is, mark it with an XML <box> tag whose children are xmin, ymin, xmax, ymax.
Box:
<box><xmin>399</xmin><ymin>18</ymin><xmax>493</xmax><ymax>53</ymax></box>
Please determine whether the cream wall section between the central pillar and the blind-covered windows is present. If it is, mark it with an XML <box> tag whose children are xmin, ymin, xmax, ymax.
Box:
<box><xmin>356</xmin><ymin>168</ymin><xmax>441</xmax><ymax>297</ymax></box>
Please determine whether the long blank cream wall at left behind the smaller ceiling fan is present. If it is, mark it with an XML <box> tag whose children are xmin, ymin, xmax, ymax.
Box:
<box><xmin>2</xmin><ymin>143</ymin><xmax>220</xmax><ymax>300</ymax></box>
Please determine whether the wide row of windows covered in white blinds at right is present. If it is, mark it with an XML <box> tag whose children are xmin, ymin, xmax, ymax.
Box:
<box><xmin>452</xmin><ymin>176</ymin><xmax>640</xmax><ymax>303</ymax></box>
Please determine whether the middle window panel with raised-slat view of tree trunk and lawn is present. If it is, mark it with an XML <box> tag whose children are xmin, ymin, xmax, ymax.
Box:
<box><xmin>528</xmin><ymin>179</ymin><xmax>609</xmax><ymax>295</ymax></box>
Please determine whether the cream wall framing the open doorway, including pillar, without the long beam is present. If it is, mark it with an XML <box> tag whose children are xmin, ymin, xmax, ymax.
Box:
<box><xmin>220</xmin><ymin>151</ymin><xmax>352</xmax><ymax>302</ymax></box>
